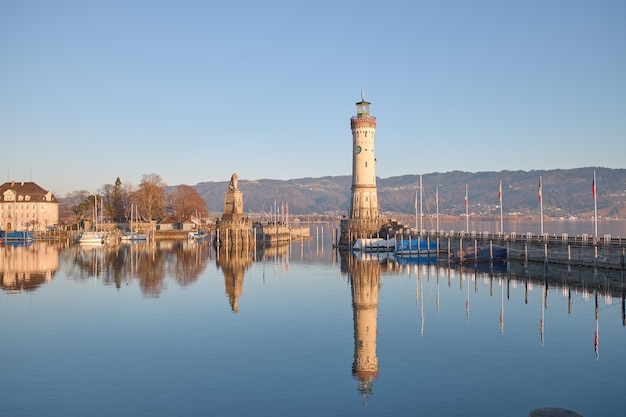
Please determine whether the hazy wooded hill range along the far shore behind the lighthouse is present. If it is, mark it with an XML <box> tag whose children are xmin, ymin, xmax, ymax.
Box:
<box><xmin>195</xmin><ymin>167</ymin><xmax>626</xmax><ymax>218</ymax></box>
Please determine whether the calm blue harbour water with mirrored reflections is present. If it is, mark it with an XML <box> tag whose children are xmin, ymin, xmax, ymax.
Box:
<box><xmin>0</xmin><ymin>226</ymin><xmax>626</xmax><ymax>417</ymax></box>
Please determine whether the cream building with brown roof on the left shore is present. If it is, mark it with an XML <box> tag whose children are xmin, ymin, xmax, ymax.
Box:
<box><xmin>0</xmin><ymin>181</ymin><xmax>59</xmax><ymax>231</ymax></box>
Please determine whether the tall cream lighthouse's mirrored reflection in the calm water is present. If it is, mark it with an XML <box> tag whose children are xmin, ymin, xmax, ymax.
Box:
<box><xmin>342</xmin><ymin>250</ymin><xmax>381</xmax><ymax>396</ymax></box>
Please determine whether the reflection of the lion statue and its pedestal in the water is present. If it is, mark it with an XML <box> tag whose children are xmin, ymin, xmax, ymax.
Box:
<box><xmin>215</xmin><ymin>247</ymin><xmax>252</xmax><ymax>313</ymax></box>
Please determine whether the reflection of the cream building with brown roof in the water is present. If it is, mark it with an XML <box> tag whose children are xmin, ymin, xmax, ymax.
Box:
<box><xmin>0</xmin><ymin>242</ymin><xmax>59</xmax><ymax>292</ymax></box>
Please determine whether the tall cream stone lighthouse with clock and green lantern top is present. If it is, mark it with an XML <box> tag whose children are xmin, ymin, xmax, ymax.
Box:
<box><xmin>349</xmin><ymin>91</ymin><xmax>379</xmax><ymax>237</ymax></box>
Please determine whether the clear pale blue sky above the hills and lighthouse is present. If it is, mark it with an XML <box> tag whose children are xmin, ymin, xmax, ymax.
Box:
<box><xmin>0</xmin><ymin>0</ymin><xmax>626</xmax><ymax>196</ymax></box>
